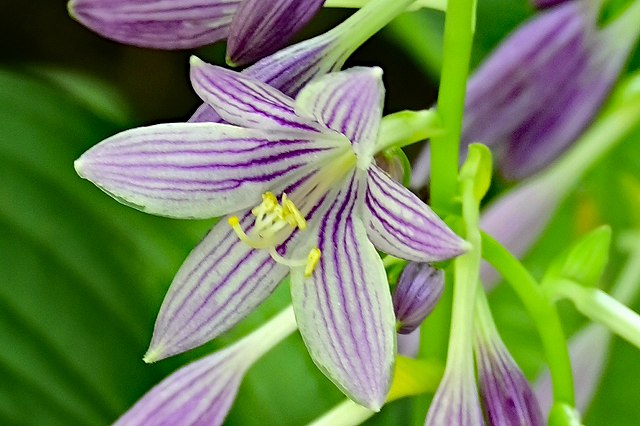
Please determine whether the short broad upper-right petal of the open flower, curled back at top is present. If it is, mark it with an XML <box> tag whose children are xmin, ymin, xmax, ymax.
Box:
<box><xmin>296</xmin><ymin>67</ymin><xmax>384</xmax><ymax>156</ymax></box>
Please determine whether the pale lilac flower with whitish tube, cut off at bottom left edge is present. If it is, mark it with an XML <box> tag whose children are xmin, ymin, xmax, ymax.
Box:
<box><xmin>115</xmin><ymin>307</ymin><xmax>296</xmax><ymax>426</ymax></box>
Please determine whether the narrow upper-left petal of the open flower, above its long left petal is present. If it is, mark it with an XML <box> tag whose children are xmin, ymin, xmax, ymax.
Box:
<box><xmin>191</xmin><ymin>56</ymin><xmax>323</xmax><ymax>132</ymax></box>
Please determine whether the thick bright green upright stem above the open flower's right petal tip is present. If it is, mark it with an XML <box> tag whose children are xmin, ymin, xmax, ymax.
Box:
<box><xmin>431</xmin><ymin>0</ymin><xmax>476</xmax><ymax>214</ymax></box>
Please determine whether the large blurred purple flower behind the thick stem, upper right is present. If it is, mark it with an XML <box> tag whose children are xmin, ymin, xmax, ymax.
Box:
<box><xmin>412</xmin><ymin>1</ymin><xmax>638</xmax><ymax>187</ymax></box>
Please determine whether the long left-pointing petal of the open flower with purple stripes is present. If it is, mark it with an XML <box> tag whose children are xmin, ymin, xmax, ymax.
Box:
<box><xmin>75</xmin><ymin>123</ymin><xmax>345</xmax><ymax>218</ymax></box>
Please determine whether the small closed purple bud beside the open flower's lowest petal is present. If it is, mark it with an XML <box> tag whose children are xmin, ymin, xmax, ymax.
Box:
<box><xmin>392</xmin><ymin>262</ymin><xmax>444</xmax><ymax>334</ymax></box>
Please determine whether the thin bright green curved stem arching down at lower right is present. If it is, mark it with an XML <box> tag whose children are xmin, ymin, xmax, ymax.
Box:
<box><xmin>482</xmin><ymin>233</ymin><xmax>575</xmax><ymax>407</ymax></box>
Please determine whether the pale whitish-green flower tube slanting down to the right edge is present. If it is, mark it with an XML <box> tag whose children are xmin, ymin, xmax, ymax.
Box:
<box><xmin>550</xmin><ymin>280</ymin><xmax>640</xmax><ymax>348</ymax></box>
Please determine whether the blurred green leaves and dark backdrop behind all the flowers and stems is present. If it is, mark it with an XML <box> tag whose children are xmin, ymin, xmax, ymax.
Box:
<box><xmin>0</xmin><ymin>0</ymin><xmax>640</xmax><ymax>425</ymax></box>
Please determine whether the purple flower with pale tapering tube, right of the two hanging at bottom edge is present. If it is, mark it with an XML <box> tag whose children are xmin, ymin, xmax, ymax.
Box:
<box><xmin>474</xmin><ymin>297</ymin><xmax>545</xmax><ymax>426</ymax></box>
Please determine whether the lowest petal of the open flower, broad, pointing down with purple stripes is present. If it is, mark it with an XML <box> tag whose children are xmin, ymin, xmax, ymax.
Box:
<box><xmin>291</xmin><ymin>174</ymin><xmax>395</xmax><ymax>410</ymax></box>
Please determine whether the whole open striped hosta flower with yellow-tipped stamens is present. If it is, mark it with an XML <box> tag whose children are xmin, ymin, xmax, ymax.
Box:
<box><xmin>76</xmin><ymin>59</ymin><xmax>466</xmax><ymax>410</ymax></box>
